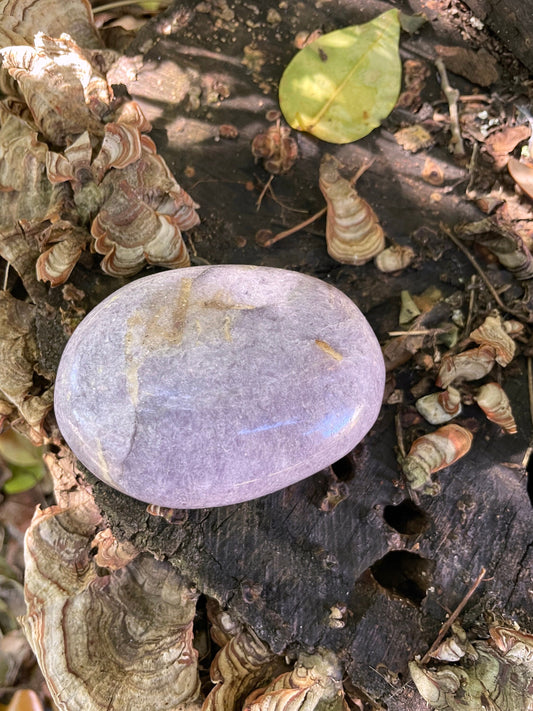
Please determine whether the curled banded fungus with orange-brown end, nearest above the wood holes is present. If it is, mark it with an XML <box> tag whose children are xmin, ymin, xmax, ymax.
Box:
<box><xmin>402</xmin><ymin>424</ymin><xmax>473</xmax><ymax>495</ymax></box>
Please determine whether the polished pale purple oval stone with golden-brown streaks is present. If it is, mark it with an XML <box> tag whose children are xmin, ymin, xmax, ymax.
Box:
<box><xmin>55</xmin><ymin>265</ymin><xmax>385</xmax><ymax>508</ymax></box>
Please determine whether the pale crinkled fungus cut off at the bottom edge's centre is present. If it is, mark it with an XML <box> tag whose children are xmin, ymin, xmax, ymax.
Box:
<box><xmin>243</xmin><ymin>650</ymin><xmax>348</xmax><ymax>711</ymax></box>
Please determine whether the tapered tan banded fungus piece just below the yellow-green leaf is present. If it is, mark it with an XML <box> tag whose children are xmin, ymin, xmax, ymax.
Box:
<box><xmin>319</xmin><ymin>154</ymin><xmax>385</xmax><ymax>265</ymax></box>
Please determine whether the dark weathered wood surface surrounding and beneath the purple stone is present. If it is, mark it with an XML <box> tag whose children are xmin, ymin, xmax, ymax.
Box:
<box><xmin>68</xmin><ymin>0</ymin><xmax>533</xmax><ymax>711</ymax></box>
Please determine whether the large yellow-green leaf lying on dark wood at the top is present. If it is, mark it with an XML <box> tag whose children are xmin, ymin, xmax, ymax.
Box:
<box><xmin>279</xmin><ymin>10</ymin><xmax>402</xmax><ymax>143</ymax></box>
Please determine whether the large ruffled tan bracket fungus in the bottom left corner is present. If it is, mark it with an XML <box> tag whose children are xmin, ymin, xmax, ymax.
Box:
<box><xmin>21</xmin><ymin>504</ymin><xmax>199</xmax><ymax>711</ymax></box>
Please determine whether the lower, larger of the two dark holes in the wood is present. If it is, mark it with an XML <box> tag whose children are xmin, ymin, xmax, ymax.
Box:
<box><xmin>370</xmin><ymin>551</ymin><xmax>435</xmax><ymax>605</ymax></box>
